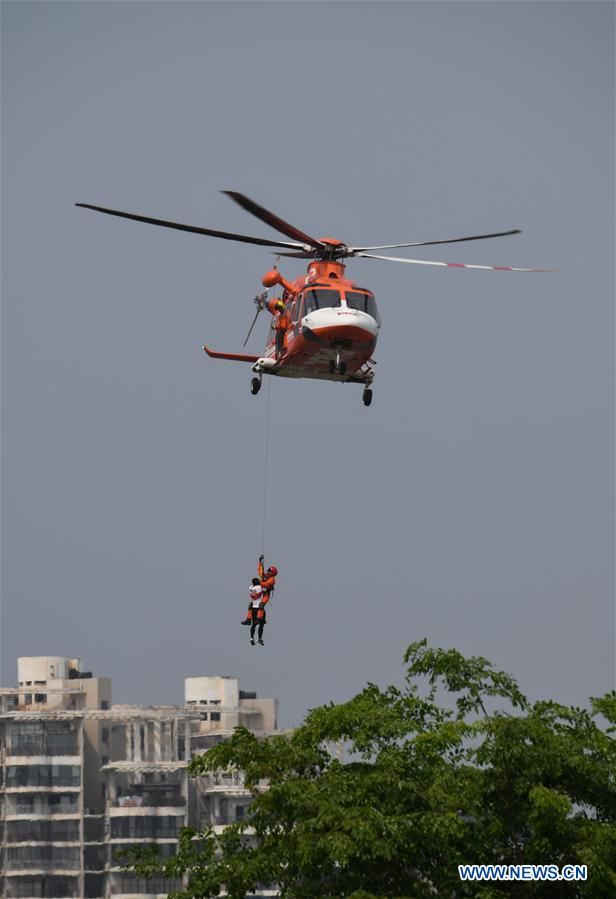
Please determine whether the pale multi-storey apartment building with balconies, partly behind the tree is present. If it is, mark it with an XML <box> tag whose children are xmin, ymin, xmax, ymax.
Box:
<box><xmin>0</xmin><ymin>656</ymin><xmax>277</xmax><ymax>899</ymax></box>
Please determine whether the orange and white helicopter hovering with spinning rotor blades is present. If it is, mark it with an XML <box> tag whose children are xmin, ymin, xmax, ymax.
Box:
<box><xmin>76</xmin><ymin>197</ymin><xmax>551</xmax><ymax>406</ymax></box>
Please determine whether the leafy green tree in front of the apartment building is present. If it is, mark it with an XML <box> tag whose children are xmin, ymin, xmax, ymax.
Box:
<box><xmin>126</xmin><ymin>640</ymin><xmax>616</xmax><ymax>899</ymax></box>
